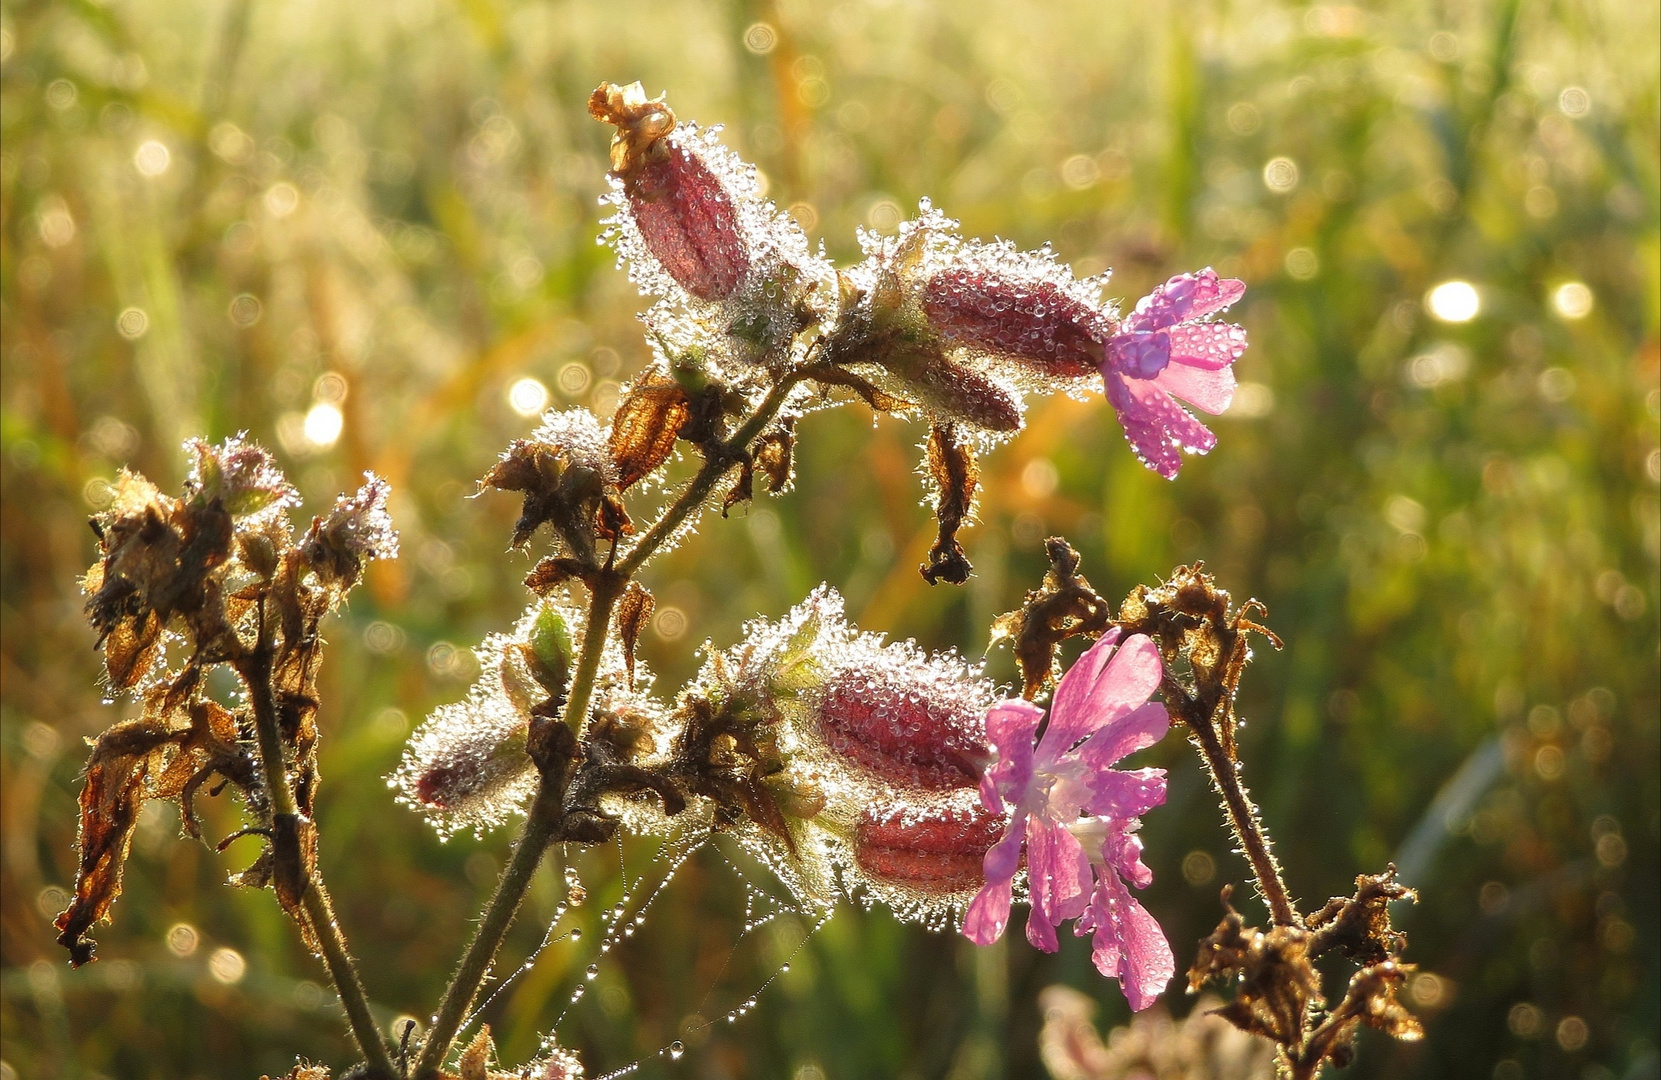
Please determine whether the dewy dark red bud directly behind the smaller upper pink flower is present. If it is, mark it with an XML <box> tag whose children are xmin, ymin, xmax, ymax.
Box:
<box><xmin>924</xmin><ymin>266</ymin><xmax>1111</xmax><ymax>379</ymax></box>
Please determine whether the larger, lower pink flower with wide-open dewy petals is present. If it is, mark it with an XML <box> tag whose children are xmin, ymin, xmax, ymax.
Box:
<box><xmin>963</xmin><ymin>628</ymin><xmax>1176</xmax><ymax>1010</ymax></box>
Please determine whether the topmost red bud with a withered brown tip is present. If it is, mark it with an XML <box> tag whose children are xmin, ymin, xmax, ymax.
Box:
<box><xmin>588</xmin><ymin>83</ymin><xmax>749</xmax><ymax>301</ymax></box>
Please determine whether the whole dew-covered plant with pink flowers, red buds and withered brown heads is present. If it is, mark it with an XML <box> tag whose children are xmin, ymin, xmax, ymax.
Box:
<box><xmin>56</xmin><ymin>85</ymin><xmax>1418</xmax><ymax>1080</ymax></box>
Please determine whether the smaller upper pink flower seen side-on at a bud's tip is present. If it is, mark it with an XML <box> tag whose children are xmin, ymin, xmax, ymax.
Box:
<box><xmin>1101</xmin><ymin>268</ymin><xmax>1246</xmax><ymax>480</ymax></box>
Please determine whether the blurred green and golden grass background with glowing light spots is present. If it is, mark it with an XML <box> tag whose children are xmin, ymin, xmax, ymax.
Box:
<box><xmin>0</xmin><ymin>0</ymin><xmax>1661</xmax><ymax>1080</ymax></box>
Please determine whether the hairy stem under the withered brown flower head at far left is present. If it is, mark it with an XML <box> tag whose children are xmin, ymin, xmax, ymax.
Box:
<box><xmin>236</xmin><ymin>638</ymin><xmax>397</xmax><ymax>1080</ymax></box>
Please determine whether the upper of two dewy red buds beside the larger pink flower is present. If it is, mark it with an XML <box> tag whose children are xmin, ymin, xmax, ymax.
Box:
<box><xmin>812</xmin><ymin>646</ymin><xmax>992</xmax><ymax>791</ymax></box>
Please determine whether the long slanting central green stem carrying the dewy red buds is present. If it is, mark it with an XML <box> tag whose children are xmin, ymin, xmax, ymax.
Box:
<box><xmin>410</xmin><ymin>366</ymin><xmax>817</xmax><ymax>1080</ymax></box>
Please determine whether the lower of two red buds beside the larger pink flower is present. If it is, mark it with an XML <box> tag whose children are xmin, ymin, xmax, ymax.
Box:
<box><xmin>854</xmin><ymin>803</ymin><xmax>1007</xmax><ymax>899</ymax></box>
